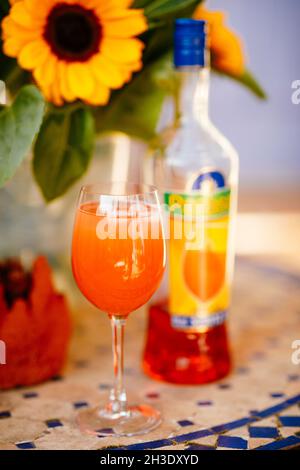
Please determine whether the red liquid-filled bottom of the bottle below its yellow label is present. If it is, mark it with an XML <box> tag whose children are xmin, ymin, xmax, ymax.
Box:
<box><xmin>143</xmin><ymin>305</ymin><xmax>231</xmax><ymax>385</ymax></box>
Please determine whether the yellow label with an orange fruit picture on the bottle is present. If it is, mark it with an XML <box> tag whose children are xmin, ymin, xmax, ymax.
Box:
<box><xmin>164</xmin><ymin>185</ymin><xmax>230</xmax><ymax>332</ymax></box>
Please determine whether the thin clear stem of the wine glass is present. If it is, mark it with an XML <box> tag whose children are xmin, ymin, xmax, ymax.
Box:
<box><xmin>109</xmin><ymin>315</ymin><xmax>127</xmax><ymax>415</ymax></box>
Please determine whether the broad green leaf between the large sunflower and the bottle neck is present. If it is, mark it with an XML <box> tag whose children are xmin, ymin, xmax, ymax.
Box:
<box><xmin>95</xmin><ymin>58</ymin><xmax>166</xmax><ymax>140</ymax></box>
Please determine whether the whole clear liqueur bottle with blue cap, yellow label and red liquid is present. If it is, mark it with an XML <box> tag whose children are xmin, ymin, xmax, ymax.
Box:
<box><xmin>143</xmin><ymin>19</ymin><xmax>238</xmax><ymax>384</ymax></box>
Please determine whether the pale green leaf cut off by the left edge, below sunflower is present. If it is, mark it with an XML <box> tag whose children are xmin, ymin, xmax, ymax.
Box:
<box><xmin>0</xmin><ymin>85</ymin><xmax>44</xmax><ymax>187</ymax></box>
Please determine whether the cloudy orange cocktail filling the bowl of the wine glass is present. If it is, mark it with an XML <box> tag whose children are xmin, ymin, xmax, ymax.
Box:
<box><xmin>72</xmin><ymin>202</ymin><xmax>164</xmax><ymax>315</ymax></box>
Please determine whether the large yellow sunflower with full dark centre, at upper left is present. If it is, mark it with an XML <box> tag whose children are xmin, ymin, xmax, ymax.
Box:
<box><xmin>2</xmin><ymin>0</ymin><xmax>147</xmax><ymax>106</ymax></box>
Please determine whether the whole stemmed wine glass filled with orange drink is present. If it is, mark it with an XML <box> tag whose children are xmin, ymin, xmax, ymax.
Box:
<box><xmin>72</xmin><ymin>183</ymin><xmax>166</xmax><ymax>436</ymax></box>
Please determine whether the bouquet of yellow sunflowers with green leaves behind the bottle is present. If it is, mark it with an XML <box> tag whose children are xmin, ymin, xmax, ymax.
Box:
<box><xmin>0</xmin><ymin>0</ymin><xmax>264</xmax><ymax>201</ymax></box>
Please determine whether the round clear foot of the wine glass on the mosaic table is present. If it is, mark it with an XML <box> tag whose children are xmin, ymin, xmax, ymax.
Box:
<box><xmin>76</xmin><ymin>405</ymin><xmax>161</xmax><ymax>437</ymax></box>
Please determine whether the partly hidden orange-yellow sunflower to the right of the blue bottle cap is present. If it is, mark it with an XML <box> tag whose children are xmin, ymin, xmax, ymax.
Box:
<box><xmin>194</xmin><ymin>5</ymin><xmax>245</xmax><ymax>77</ymax></box>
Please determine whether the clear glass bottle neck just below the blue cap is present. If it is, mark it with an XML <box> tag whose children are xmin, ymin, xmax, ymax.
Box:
<box><xmin>176</xmin><ymin>66</ymin><xmax>209</xmax><ymax>125</ymax></box>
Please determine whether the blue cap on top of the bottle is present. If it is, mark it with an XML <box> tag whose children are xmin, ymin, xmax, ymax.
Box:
<box><xmin>174</xmin><ymin>18</ymin><xmax>206</xmax><ymax>67</ymax></box>
